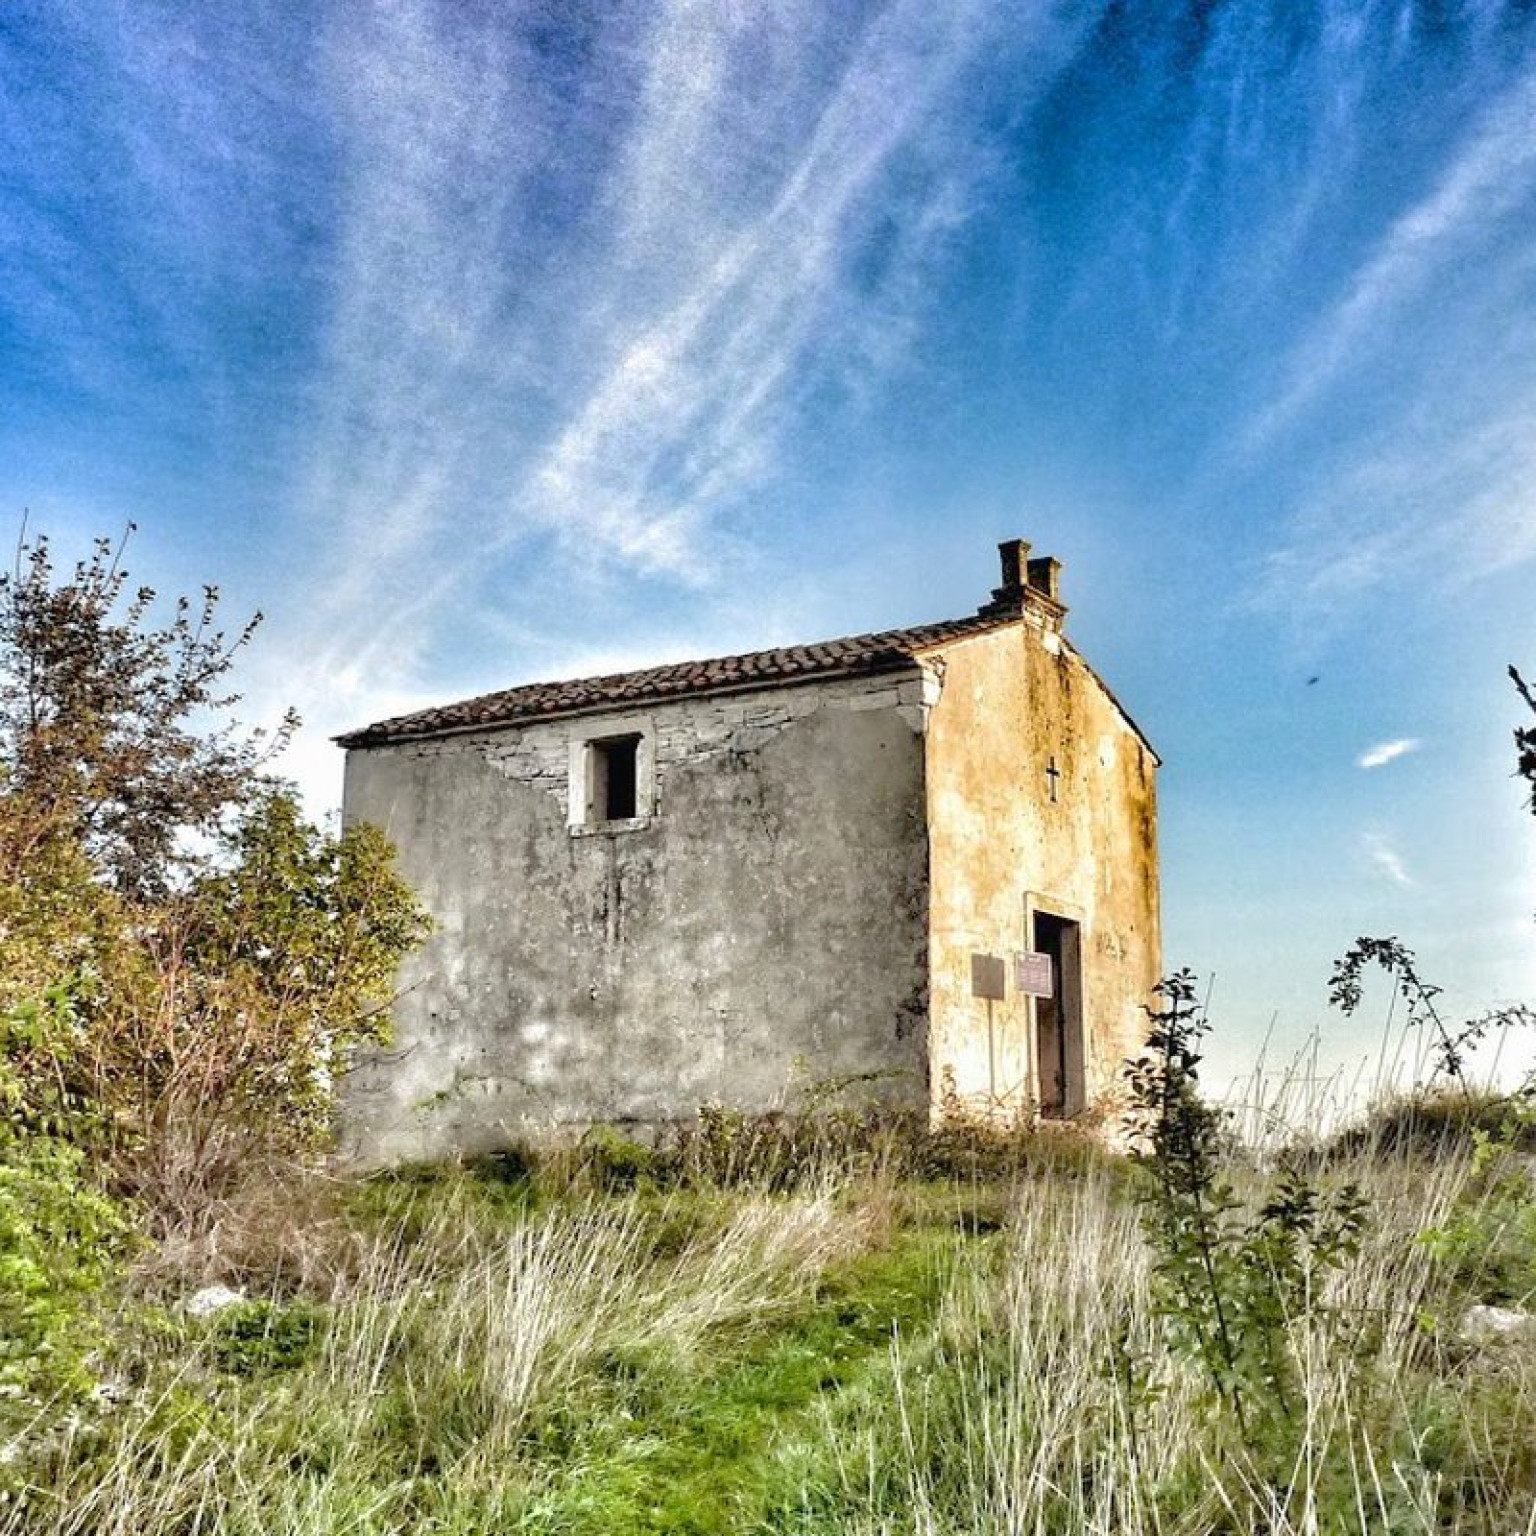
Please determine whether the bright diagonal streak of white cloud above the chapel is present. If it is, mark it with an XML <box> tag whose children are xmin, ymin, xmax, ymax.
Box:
<box><xmin>522</xmin><ymin>3</ymin><xmax>995</xmax><ymax>576</ymax></box>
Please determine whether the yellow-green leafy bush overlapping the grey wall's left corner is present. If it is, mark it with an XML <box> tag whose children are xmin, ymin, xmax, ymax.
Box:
<box><xmin>95</xmin><ymin>790</ymin><xmax>427</xmax><ymax>1220</ymax></box>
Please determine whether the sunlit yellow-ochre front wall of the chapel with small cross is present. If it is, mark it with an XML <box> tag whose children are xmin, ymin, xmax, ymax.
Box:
<box><xmin>925</xmin><ymin>610</ymin><xmax>1161</xmax><ymax>1106</ymax></box>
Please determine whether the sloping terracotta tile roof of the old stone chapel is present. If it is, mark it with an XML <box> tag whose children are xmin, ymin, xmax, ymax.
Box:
<box><xmin>336</xmin><ymin>610</ymin><xmax>1017</xmax><ymax>748</ymax></box>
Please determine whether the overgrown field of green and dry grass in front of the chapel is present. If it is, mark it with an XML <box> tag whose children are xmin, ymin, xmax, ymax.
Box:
<box><xmin>9</xmin><ymin>1118</ymin><xmax>1536</xmax><ymax>1536</ymax></box>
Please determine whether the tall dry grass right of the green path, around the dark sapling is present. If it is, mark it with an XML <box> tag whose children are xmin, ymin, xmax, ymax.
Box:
<box><xmin>816</xmin><ymin>1152</ymin><xmax>1536</xmax><ymax>1536</ymax></box>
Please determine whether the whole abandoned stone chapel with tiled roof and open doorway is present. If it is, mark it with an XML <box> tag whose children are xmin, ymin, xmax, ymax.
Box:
<box><xmin>338</xmin><ymin>539</ymin><xmax>1160</xmax><ymax>1163</ymax></box>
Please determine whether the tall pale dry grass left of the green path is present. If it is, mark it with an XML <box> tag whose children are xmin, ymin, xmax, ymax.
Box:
<box><xmin>0</xmin><ymin>1187</ymin><xmax>866</xmax><ymax>1536</ymax></box>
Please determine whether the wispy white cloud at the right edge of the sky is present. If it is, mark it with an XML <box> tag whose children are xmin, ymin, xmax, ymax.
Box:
<box><xmin>1241</xmin><ymin>48</ymin><xmax>1536</xmax><ymax>622</ymax></box>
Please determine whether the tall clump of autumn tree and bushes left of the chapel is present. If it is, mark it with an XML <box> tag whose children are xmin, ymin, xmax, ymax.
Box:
<box><xmin>0</xmin><ymin>539</ymin><xmax>427</xmax><ymax>1218</ymax></box>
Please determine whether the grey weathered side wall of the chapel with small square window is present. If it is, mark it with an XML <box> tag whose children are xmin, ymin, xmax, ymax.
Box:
<box><xmin>344</xmin><ymin>671</ymin><xmax>928</xmax><ymax>1161</ymax></box>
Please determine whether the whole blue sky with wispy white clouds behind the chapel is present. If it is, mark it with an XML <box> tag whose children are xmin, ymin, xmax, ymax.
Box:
<box><xmin>0</xmin><ymin>0</ymin><xmax>1536</xmax><ymax>1072</ymax></box>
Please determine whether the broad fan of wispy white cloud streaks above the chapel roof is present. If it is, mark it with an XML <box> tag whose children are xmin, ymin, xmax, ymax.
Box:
<box><xmin>270</xmin><ymin>0</ymin><xmax>1091</xmax><ymax>743</ymax></box>
